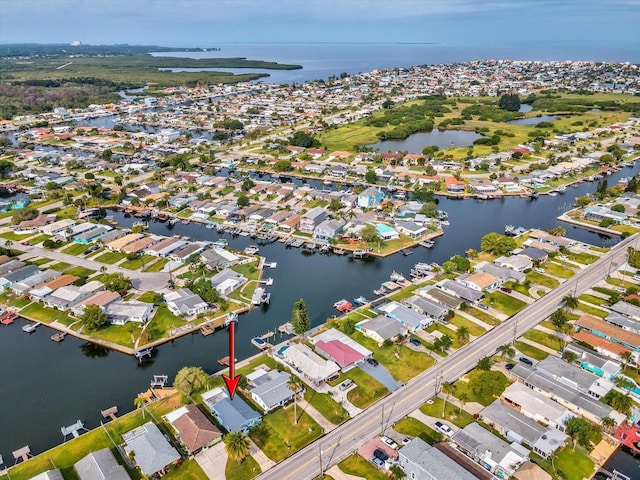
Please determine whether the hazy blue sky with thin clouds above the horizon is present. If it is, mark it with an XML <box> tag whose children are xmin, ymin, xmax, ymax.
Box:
<box><xmin>0</xmin><ymin>0</ymin><xmax>640</xmax><ymax>50</ymax></box>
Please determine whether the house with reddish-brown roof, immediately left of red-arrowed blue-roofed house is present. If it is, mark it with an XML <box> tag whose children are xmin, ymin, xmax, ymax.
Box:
<box><xmin>164</xmin><ymin>404</ymin><xmax>222</xmax><ymax>456</ymax></box>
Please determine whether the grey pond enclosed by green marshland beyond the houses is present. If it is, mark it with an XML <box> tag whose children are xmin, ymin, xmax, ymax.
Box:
<box><xmin>367</xmin><ymin>128</ymin><xmax>482</xmax><ymax>153</ymax></box>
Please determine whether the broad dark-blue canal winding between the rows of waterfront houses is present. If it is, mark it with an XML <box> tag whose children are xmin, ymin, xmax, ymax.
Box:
<box><xmin>0</xmin><ymin>164</ymin><xmax>640</xmax><ymax>458</ymax></box>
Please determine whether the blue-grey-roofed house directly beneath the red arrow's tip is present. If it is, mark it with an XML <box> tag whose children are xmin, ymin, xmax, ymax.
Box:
<box><xmin>202</xmin><ymin>387</ymin><xmax>262</xmax><ymax>433</ymax></box>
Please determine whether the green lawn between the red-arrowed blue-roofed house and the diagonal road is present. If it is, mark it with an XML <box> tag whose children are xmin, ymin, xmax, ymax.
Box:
<box><xmin>249</xmin><ymin>405</ymin><xmax>322</xmax><ymax>462</ymax></box>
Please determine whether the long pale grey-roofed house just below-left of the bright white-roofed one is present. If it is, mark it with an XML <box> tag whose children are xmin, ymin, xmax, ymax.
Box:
<box><xmin>480</xmin><ymin>400</ymin><xmax>567</xmax><ymax>458</ymax></box>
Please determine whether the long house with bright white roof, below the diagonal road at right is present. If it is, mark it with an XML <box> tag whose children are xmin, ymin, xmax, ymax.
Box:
<box><xmin>501</xmin><ymin>382</ymin><xmax>574</xmax><ymax>432</ymax></box>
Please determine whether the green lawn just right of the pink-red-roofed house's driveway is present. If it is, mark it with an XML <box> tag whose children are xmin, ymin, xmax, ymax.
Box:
<box><xmin>351</xmin><ymin>331</ymin><xmax>438</xmax><ymax>383</ymax></box>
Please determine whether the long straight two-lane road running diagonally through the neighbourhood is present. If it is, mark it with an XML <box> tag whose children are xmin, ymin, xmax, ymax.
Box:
<box><xmin>256</xmin><ymin>235</ymin><xmax>640</xmax><ymax>480</ymax></box>
